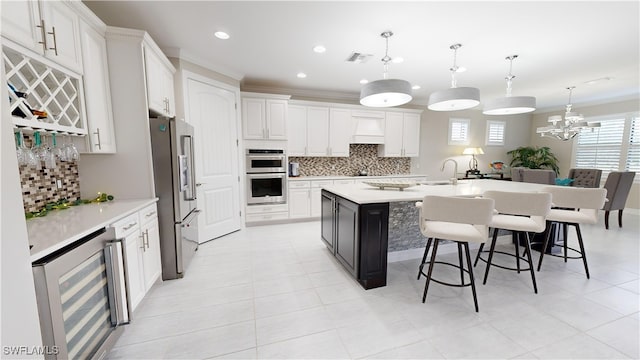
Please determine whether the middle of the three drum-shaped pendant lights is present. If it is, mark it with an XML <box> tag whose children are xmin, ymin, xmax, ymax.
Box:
<box><xmin>427</xmin><ymin>44</ymin><xmax>480</xmax><ymax>111</ymax></box>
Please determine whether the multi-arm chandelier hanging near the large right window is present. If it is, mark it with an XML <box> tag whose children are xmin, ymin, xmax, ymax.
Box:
<box><xmin>536</xmin><ymin>86</ymin><xmax>600</xmax><ymax>141</ymax></box>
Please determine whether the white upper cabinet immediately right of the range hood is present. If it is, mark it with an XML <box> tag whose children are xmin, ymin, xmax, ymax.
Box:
<box><xmin>378</xmin><ymin>111</ymin><xmax>420</xmax><ymax>157</ymax></box>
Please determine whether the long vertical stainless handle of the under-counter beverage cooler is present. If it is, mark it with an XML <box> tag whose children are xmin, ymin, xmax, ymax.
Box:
<box><xmin>105</xmin><ymin>239</ymin><xmax>131</xmax><ymax>326</ymax></box>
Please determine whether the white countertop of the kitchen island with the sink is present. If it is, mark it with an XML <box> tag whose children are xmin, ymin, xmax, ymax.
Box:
<box><xmin>324</xmin><ymin>179</ymin><xmax>552</xmax><ymax>204</ymax></box>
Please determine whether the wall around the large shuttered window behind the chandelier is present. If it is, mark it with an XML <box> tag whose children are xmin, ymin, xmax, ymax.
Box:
<box><xmin>529</xmin><ymin>99</ymin><xmax>640</xmax><ymax>209</ymax></box>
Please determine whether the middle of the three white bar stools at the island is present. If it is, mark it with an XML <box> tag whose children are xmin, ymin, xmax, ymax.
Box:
<box><xmin>473</xmin><ymin>191</ymin><xmax>551</xmax><ymax>294</ymax></box>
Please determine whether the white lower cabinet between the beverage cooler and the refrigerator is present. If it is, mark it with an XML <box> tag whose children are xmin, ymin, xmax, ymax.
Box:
<box><xmin>111</xmin><ymin>204</ymin><xmax>162</xmax><ymax>311</ymax></box>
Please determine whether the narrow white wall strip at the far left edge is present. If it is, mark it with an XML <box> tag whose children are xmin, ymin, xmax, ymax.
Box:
<box><xmin>0</xmin><ymin>56</ymin><xmax>42</xmax><ymax>359</ymax></box>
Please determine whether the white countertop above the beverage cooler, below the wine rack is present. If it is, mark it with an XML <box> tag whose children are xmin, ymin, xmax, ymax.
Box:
<box><xmin>27</xmin><ymin>199</ymin><xmax>158</xmax><ymax>261</ymax></box>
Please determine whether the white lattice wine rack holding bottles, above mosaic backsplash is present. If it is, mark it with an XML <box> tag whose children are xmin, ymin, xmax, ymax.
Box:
<box><xmin>2</xmin><ymin>47</ymin><xmax>87</xmax><ymax>135</ymax></box>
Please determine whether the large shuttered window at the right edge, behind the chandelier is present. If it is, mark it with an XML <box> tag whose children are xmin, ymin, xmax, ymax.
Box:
<box><xmin>573</xmin><ymin>114</ymin><xmax>640</xmax><ymax>178</ymax></box>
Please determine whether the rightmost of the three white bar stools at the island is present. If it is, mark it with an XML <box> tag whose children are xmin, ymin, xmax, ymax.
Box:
<box><xmin>538</xmin><ymin>186</ymin><xmax>607</xmax><ymax>279</ymax></box>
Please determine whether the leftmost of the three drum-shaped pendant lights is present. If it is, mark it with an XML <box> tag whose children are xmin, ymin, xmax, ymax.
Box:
<box><xmin>360</xmin><ymin>31</ymin><xmax>412</xmax><ymax>107</ymax></box>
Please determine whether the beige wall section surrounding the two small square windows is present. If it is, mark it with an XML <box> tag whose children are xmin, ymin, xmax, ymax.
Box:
<box><xmin>411</xmin><ymin>109</ymin><xmax>531</xmax><ymax>180</ymax></box>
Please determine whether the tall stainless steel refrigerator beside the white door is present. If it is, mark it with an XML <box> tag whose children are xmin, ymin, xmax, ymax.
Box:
<box><xmin>149</xmin><ymin>117</ymin><xmax>200</xmax><ymax>280</ymax></box>
